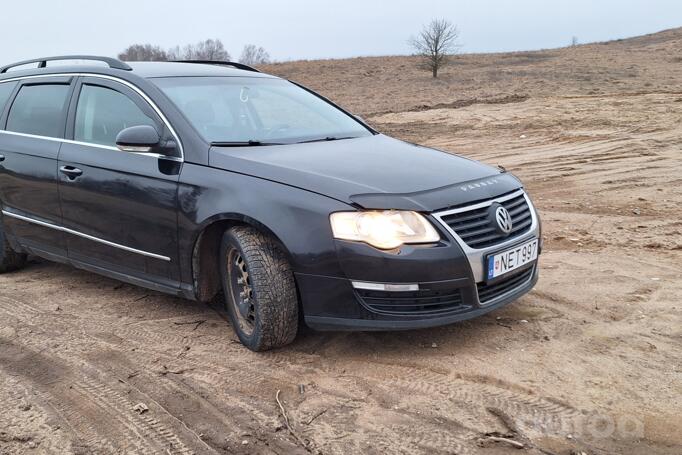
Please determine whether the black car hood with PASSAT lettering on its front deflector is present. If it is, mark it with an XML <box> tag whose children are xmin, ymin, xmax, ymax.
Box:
<box><xmin>209</xmin><ymin>134</ymin><xmax>521</xmax><ymax>211</ymax></box>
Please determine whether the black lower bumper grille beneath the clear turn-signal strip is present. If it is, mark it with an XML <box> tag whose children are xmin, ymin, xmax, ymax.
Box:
<box><xmin>356</xmin><ymin>288</ymin><xmax>468</xmax><ymax>316</ymax></box>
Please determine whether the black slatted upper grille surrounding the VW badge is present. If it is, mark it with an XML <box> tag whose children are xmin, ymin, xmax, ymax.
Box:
<box><xmin>442</xmin><ymin>193</ymin><xmax>533</xmax><ymax>249</ymax></box>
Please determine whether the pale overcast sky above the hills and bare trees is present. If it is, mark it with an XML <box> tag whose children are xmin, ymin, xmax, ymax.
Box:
<box><xmin>0</xmin><ymin>0</ymin><xmax>682</xmax><ymax>63</ymax></box>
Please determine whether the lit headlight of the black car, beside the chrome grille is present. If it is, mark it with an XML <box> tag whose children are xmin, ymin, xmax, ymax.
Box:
<box><xmin>329</xmin><ymin>210</ymin><xmax>440</xmax><ymax>250</ymax></box>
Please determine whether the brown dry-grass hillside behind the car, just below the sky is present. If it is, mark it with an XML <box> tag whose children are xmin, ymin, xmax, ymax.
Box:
<box><xmin>262</xmin><ymin>28</ymin><xmax>682</xmax><ymax>115</ymax></box>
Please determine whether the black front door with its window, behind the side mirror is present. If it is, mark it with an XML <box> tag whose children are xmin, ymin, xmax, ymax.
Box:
<box><xmin>58</xmin><ymin>77</ymin><xmax>182</xmax><ymax>287</ymax></box>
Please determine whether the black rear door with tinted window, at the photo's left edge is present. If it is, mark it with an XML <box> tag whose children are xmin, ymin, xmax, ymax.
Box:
<box><xmin>0</xmin><ymin>77</ymin><xmax>73</xmax><ymax>257</ymax></box>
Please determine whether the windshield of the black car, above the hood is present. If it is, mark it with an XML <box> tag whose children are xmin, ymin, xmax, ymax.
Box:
<box><xmin>154</xmin><ymin>77</ymin><xmax>372</xmax><ymax>145</ymax></box>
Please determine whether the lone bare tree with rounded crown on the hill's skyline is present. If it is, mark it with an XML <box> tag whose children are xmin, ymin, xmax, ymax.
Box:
<box><xmin>408</xmin><ymin>19</ymin><xmax>459</xmax><ymax>77</ymax></box>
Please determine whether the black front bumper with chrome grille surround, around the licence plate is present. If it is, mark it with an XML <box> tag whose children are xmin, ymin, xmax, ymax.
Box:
<box><xmin>296</xmin><ymin>189</ymin><xmax>541</xmax><ymax>330</ymax></box>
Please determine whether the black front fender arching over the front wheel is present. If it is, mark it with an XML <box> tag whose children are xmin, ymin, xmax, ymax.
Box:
<box><xmin>178</xmin><ymin>163</ymin><xmax>352</xmax><ymax>283</ymax></box>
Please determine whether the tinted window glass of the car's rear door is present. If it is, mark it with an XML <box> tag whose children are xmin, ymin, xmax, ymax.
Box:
<box><xmin>7</xmin><ymin>84</ymin><xmax>69</xmax><ymax>138</ymax></box>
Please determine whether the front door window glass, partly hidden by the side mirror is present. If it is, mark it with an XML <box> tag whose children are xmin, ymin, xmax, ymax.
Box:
<box><xmin>74</xmin><ymin>85</ymin><xmax>156</xmax><ymax>147</ymax></box>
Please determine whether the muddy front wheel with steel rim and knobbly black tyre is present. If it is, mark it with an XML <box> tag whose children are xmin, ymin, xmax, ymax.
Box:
<box><xmin>220</xmin><ymin>226</ymin><xmax>298</xmax><ymax>351</ymax></box>
